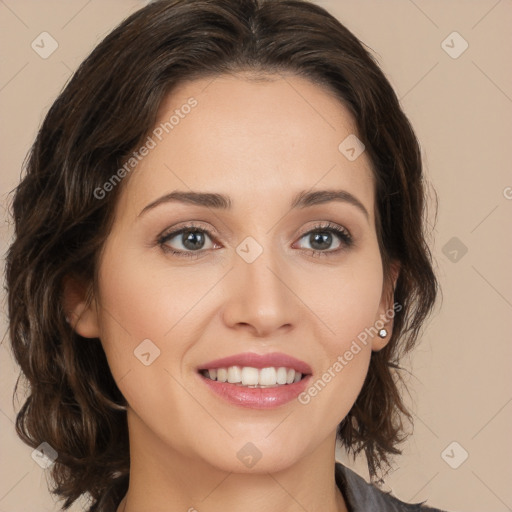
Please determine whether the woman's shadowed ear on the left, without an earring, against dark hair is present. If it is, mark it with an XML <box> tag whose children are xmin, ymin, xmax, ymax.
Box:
<box><xmin>62</xmin><ymin>276</ymin><xmax>100</xmax><ymax>338</ymax></box>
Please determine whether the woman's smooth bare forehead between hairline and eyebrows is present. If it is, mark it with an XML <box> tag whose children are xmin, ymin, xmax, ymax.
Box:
<box><xmin>116</xmin><ymin>75</ymin><xmax>374</xmax><ymax>217</ymax></box>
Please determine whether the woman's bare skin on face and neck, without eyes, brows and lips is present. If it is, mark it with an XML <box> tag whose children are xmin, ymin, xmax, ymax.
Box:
<box><xmin>67</xmin><ymin>74</ymin><xmax>396</xmax><ymax>512</ymax></box>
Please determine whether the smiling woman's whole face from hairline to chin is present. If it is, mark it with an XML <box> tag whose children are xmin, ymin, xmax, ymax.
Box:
<box><xmin>69</xmin><ymin>72</ymin><xmax>392</xmax><ymax>472</ymax></box>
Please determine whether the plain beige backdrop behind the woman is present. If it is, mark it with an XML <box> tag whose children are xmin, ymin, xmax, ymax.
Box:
<box><xmin>0</xmin><ymin>0</ymin><xmax>512</xmax><ymax>512</ymax></box>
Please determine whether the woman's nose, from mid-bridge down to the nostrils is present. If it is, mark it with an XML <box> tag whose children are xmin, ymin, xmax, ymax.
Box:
<box><xmin>223</xmin><ymin>249</ymin><xmax>300</xmax><ymax>337</ymax></box>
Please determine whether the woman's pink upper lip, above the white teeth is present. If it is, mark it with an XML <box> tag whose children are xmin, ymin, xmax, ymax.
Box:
<box><xmin>198</xmin><ymin>352</ymin><xmax>313</xmax><ymax>374</ymax></box>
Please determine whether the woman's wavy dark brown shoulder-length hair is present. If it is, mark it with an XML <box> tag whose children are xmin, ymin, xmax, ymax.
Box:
<box><xmin>6</xmin><ymin>0</ymin><xmax>437</xmax><ymax>511</ymax></box>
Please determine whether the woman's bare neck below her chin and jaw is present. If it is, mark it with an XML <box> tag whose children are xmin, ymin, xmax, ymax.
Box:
<box><xmin>117</xmin><ymin>411</ymin><xmax>347</xmax><ymax>512</ymax></box>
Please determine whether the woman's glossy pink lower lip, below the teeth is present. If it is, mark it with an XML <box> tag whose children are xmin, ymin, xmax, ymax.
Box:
<box><xmin>199</xmin><ymin>374</ymin><xmax>311</xmax><ymax>409</ymax></box>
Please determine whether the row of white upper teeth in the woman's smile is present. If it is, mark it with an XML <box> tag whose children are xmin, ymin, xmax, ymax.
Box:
<box><xmin>202</xmin><ymin>366</ymin><xmax>302</xmax><ymax>387</ymax></box>
